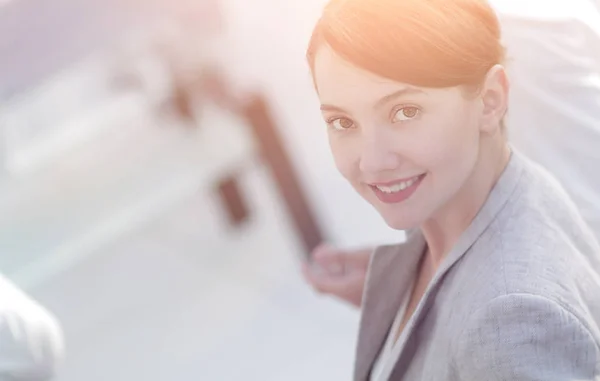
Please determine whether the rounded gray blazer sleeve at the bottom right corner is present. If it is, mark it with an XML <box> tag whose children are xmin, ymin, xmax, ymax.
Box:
<box><xmin>455</xmin><ymin>294</ymin><xmax>600</xmax><ymax>381</ymax></box>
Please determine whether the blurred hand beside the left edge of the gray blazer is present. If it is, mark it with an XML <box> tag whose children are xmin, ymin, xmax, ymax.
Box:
<box><xmin>302</xmin><ymin>244</ymin><xmax>374</xmax><ymax>308</ymax></box>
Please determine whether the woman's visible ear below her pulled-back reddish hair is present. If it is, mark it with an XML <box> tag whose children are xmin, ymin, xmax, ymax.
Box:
<box><xmin>481</xmin><ymin>65</ymin><xmax>510</xmax><ymax>134</ymax></box>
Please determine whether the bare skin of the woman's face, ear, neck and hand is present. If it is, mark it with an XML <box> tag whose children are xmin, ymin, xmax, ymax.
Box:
<box><xmin>304</xmin><ymin>45</ymin><xmax>510</xmax><ymax>317</ymax></box>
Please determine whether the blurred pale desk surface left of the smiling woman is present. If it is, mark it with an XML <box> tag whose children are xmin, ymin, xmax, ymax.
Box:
<box><xmin>0</xmin><ymin>98</ymin><xmax>358</xmax><ymax>381</ymax></box>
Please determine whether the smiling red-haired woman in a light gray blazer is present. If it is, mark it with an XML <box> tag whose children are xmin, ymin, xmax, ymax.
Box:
<box><xmin>307</xmin><ymin>0</ymin><xmax>600</xmax><ymax>381</ymax></box>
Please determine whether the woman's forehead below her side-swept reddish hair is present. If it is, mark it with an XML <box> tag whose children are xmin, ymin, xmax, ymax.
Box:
<box><xmin>313</xmin><ymin>45</ymin><xmax>423</xmax><ymax>104</ymax></box>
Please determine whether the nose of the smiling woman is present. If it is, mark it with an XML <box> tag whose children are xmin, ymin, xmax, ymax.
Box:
<box><xmin>359</xmin><ymin>129</ymin><xmax>401</xmax><ymax>173</ymax></box>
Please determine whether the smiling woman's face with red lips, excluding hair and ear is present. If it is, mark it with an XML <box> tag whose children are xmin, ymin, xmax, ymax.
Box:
<box><xmin>314</xmin><ymin>45</ymin><xmax>483</xmax><ymax>229</ymax></box>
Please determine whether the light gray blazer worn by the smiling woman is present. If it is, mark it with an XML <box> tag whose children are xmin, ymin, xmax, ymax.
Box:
<box><xmin>354</xmin><ymin>152</ymin><xmax>600</xmax><ymax>381</ymax></box>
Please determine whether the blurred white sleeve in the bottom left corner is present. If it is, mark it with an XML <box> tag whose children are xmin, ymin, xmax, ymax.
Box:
<box><xmin>0</xmin><ymin>277</ymin><xmax>64</xmax><ymax>381</ymax></box>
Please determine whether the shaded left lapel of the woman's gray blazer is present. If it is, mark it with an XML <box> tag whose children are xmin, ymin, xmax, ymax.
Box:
<box><xmin>354</xmin><ymin>231</ymin><xmax>425</xmax><ymax>381</ymax></box>
